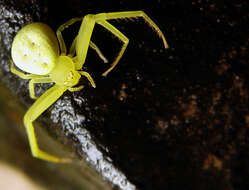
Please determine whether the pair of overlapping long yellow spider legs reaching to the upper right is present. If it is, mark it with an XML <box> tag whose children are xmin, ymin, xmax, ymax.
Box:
<box><xmin>76</xmin><ymin>11</ymin><xmax>168</xmax><ymax>76</ymax></box>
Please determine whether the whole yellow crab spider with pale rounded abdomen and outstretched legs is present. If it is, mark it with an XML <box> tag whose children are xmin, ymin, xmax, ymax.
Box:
<box><xmin>11</xmin><ymin>11</ymin><xmax>168</xmax><ymax>162</ymax></box>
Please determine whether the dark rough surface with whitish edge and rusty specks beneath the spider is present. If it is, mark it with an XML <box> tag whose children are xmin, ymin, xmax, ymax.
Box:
<box><xmin>0</xmin><ymin>0</ymin><xmax>249</xmax><ymax>190</ymax></box>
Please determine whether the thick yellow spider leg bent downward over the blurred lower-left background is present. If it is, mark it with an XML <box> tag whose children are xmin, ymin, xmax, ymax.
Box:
<box><xmin>24</xmin><ymin>85</ymin><xmax>71</xmax><ymax>162</ymax></box>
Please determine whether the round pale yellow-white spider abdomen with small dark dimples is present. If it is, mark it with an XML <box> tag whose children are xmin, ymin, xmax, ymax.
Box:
<box><xmin>11</xmin><ymin>22</ymin><xmax>59</xmax><ymax>75</ymax></box>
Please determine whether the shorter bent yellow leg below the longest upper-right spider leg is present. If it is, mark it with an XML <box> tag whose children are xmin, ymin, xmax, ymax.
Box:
<box><xmin>97</xmin><ymin>20</ymin><xmax>129</xmax><ymax>76</ymax></box>
